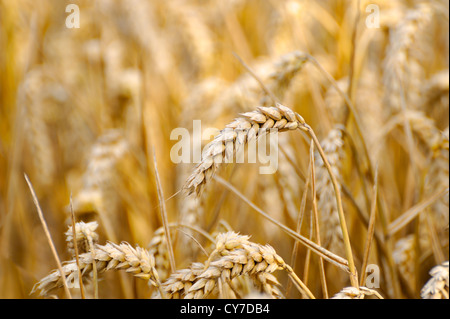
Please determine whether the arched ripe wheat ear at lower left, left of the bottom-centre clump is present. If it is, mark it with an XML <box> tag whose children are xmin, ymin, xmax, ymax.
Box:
<box><xmin>31</xmin><ymin>242</ymin><xmax>160</xmax><ymax>296</ymax></box>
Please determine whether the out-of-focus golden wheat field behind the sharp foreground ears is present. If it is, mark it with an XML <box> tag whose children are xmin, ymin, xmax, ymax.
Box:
<box><xmin>0</xmin><ymin>0</ymin><xmax>449</xmax><ymax>298</ymax></box>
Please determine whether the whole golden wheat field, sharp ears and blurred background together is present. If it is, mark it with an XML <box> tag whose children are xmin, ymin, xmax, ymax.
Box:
<box><xmin>0</xmin><ymin>0</ymin><xmax>449</xmax><ymax>299</ymax></box>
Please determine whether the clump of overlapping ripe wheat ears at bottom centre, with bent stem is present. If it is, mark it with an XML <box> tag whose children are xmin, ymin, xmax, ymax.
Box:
<box><xmin>163</xmin><ymin>232</ymin><xmax>314</xmax><ymax>299</ymax></box>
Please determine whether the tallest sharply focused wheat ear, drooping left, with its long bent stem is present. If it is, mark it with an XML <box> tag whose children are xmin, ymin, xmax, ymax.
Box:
<box><xmin>184</xmin><ymin>103</ymin><xmax>359</xmax><ymax>287</ymax></box>
